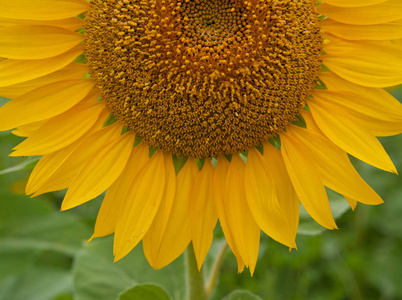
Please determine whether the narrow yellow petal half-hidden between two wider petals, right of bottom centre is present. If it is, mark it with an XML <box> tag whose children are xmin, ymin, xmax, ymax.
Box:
<box><xmin>264</xmin><ymin>143</ymin><xmax>300</xmax><ymax>241</ymax></box>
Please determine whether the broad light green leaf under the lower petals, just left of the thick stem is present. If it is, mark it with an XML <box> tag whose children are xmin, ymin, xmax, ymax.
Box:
<box><xmin>73</xmin><ymin>236</ymin><xmax>185</xmax><ymax>300</ymax></box>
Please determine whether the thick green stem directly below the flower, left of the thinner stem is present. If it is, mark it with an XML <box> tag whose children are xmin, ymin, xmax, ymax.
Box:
<box><xmin>185</xmin><ymin>244</ymin><xmax>207</xmax><ymax>300</ymax></box>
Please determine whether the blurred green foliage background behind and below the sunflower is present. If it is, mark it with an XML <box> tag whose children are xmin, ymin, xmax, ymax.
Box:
<box><xmin>0</xmin><ymin>88</ymin><xmax>402</xmax><ymax>300</ymax></box>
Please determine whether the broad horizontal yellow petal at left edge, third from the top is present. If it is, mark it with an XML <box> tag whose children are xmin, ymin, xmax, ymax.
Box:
<box><xmin>0</xmin><ymin>25</ymin><xmax>84</xmax><ymax>59</ymax></box>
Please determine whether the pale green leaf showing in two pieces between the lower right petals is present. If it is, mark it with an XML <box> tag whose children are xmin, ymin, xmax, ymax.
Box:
<box><xmin>298</xmin><ymin>189</ymin><xmax>350</xmax><ymax>235</ymax></box>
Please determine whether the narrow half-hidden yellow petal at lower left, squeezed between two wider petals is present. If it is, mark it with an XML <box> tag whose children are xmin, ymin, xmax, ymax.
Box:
<box><xmin>25</xmin><ymin>110</ymin><xmax>109</xmax><ymax>195</ymax></box>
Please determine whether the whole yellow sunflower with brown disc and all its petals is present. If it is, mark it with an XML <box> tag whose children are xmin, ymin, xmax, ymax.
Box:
<box><xmin>0</xmin><ymin>0</ymin><xmax>402</xmax><ymax>273</ymax></box>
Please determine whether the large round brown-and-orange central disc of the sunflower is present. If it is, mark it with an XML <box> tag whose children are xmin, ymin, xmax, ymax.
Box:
<box><xmin>85</xmin><ymin>0</ymin><xmax>322</xmax><ymax>158</ymax></box>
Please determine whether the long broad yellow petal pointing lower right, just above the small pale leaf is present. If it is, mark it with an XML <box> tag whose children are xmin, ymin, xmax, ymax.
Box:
<box><xmin>292</xmin><ymin>126</ymin><xmax>383</xmax><ymax>204</ymax></box>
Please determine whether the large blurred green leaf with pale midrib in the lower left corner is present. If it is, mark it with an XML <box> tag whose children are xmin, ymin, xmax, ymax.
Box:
<box><xmin>0</xmin><ymin>189</ymin><xmax>89</xmax><ymax>300</ymax></box>
